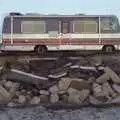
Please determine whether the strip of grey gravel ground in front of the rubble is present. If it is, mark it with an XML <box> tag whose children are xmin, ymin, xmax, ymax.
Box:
<box><xmin>0</xmin><ymin>106</ymin><xmax>120</xmax><ymax>120</ymax></box>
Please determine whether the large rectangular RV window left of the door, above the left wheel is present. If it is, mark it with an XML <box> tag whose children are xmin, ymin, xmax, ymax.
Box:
<box><xmin>21</xmin><ymin>21</ymin><xmax>46</xmax><ymax>34</ymax></box>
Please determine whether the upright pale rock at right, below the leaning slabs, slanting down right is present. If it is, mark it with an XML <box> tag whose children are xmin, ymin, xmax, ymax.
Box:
<box><xmin>102</xmin><ymin>82</ymin><xmax>116</xmax><ymax>97</ymax></box>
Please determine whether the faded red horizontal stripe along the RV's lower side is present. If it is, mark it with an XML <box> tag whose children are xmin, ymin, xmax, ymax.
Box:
<box><xmin>3</xmin><ymin>38</ymin><xmax>120</xmax><ymax>45</ymax></box>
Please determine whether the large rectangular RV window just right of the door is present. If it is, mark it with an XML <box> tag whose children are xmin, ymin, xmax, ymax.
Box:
<box><xmin>73</xmin><ymin>20</ymin><xmax>98</xmax><ymax>33</ymax></box>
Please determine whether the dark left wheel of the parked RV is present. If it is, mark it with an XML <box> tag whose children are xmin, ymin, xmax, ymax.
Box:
<box><xmin>35</xmin><ymin>46</ymin><xmax>47</xmax><ymax>56</ymax></box>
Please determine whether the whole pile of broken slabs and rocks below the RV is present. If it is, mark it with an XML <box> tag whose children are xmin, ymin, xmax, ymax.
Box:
<box><xmin>0</xmin><ymin>58</ymin><xmax>120</xmax><ymax>106</ymax></box>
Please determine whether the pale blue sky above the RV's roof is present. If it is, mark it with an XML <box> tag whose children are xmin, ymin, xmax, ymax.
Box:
<box><xmin>0</xmin><ymin>0</ymin><xmax>120</xmax><ymax>31</ymax></box>
